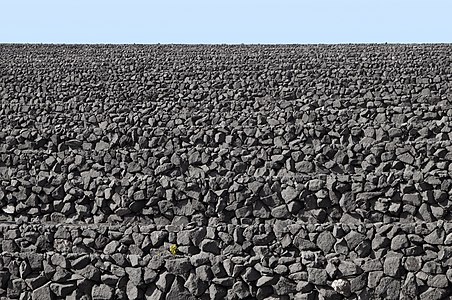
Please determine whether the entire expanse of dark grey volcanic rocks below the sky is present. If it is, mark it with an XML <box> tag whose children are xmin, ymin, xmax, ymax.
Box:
<box><xmin>0</xmin><ymin>44</ymin><xmax>452</xmax><ymax>300</ymax></box>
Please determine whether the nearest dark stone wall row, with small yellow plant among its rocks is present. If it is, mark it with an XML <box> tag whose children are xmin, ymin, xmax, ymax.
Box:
<box><xmin>0</xmin><ymin>220</ymin><xmax>452</xmax><ymax>299</ymax></box>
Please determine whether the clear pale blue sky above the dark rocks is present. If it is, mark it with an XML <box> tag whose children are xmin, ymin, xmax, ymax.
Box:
<box><xmin>0</xmin><ymin>0</ymin><xmax>452</xmax><ymax>44</ymax></box>
